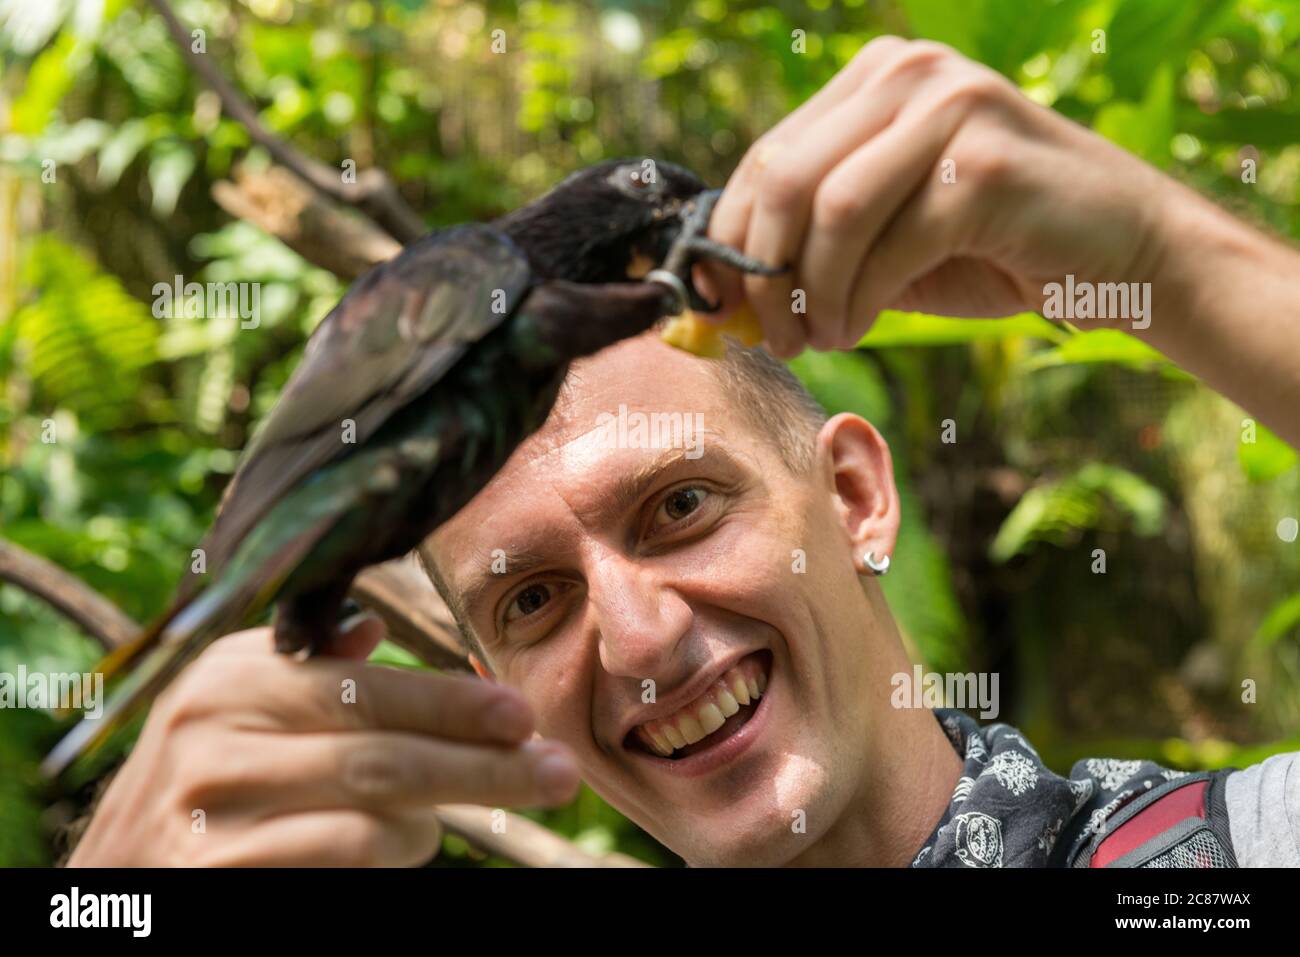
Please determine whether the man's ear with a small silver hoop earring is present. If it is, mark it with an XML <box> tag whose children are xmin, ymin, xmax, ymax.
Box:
<box><xmin>816</xmin><ymin>412</ymin><xmax>898</xmax><ymax>573</ymax></box>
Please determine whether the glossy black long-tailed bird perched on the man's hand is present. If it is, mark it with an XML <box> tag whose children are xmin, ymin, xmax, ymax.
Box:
<box><xmin>43</xmin><ymin>160</ymin><xmax>775</xmax><ymax>776</ymax></box>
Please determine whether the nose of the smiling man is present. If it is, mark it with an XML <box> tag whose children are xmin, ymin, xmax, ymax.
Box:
<box><xmin>588</xmin><ymin>555</ymin><xmax>693</xmax><ymax>679</ymax></box>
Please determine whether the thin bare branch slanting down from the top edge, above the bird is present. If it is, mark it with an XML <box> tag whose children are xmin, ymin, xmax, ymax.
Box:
<box><xmin>150</xmin><ymin>0</ymin><xmax>429</xmax><ymax>243</ymax></box>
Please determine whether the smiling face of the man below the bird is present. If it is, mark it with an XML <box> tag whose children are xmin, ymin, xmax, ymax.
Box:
<box><xmin>432</xmin><ymin>335</ymin><xmax>897</xmax><ymax>865</ymax></box>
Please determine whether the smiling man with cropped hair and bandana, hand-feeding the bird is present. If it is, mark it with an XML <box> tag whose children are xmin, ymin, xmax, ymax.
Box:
<box><xmin>63</xmin><ymin>38</ymin><xmax>1300</xmax><ymax>866</ymax></box>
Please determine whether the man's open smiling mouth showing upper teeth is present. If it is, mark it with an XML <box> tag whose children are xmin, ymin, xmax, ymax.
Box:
<box><xmin>624</xmin><ymin>650</ymin><xmax>772</xmax><ymax>761</ymax></box>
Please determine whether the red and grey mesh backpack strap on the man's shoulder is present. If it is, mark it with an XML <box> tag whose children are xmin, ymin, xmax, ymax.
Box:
<box><xmin>1074</xmin><ymin>768</ymin><xmax>1236</xmax><ymax>867</ymax></box>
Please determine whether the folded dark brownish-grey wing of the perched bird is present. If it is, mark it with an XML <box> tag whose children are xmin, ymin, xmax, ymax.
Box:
<box><xmin>203</xmin><ymin>225</ymin><xmax>532</xmax><ymax>582</ymax></box>
